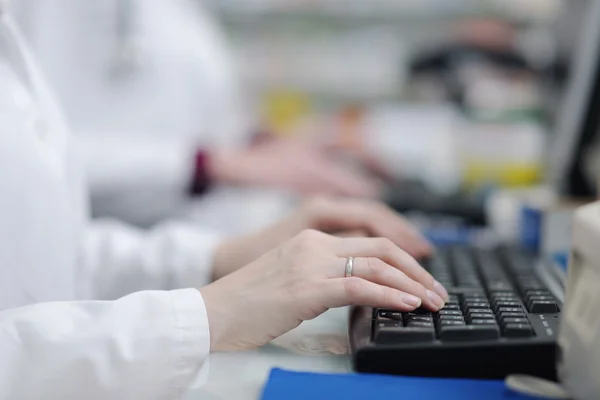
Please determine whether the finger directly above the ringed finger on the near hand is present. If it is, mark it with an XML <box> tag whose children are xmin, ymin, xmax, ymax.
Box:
<box><xmin>334</xmin><ymin>238</ymin><xmax>448</xmax><ymax>300</ymax></box>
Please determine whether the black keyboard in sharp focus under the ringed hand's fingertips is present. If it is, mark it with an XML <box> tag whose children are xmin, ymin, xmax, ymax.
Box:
<box><xmin>350</xmin><ymin>248</ymin><xmax>562</xmax><ymax>379</ymax></box>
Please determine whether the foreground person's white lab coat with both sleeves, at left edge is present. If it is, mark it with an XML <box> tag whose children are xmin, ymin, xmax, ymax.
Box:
<box><xmin>0</xmin><ymin>10</ymin><xmax>217</xmax><ymax>400</ymax></box>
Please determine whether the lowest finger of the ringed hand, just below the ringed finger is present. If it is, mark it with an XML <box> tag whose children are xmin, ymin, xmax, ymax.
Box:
<box><xmin>317</xmin><ymin>277</ymin><xmax>421</xmax><ymax>312</ymax></box>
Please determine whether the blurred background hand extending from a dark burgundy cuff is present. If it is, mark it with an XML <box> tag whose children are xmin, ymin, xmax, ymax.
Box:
<box><xmin>210</xmin><ymin>139</ymin><xmax>379</xmax><ymax>198</ymax></box>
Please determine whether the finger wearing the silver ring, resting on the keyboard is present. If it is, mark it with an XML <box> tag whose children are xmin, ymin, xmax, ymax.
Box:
<box><xmin>338</xmin><ymin>257</ymin><xmax>444</xmax><ymax>311</ymax></box>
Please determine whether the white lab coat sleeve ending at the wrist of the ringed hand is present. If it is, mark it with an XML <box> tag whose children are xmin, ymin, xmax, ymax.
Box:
<box><xmin>0</xmin><ymin>289</ymin><xmax>210</xmax><ymax>400</ymax></box>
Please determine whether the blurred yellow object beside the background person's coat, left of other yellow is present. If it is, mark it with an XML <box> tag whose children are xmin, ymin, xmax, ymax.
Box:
<box><xmin>263</xmin><ymin>90</ymin><xmax>312</xmax><ymax>135</ymax></box>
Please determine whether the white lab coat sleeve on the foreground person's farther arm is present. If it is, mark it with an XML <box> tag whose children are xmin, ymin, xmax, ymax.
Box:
<box><xmin>78</xmin><ymin>220</ymin><xmax>220</xmax><ymax>300</ymax></box>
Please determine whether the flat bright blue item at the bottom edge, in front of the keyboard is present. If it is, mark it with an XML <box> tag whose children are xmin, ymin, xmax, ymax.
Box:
<box><xmin>262</xmin><ymin>369</ymin><xmax>539</xmax><ymax>400</ymax></box>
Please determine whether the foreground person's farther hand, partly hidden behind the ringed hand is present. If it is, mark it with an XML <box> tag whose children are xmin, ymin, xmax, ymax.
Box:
<box><xmin>213</xmin><ymin>197</ymin><xmax>431</xmax><ymax>279</ymax></box>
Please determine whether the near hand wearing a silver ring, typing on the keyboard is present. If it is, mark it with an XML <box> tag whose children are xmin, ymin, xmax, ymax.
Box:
<box><xmin>200</xmin><ymin>230</ymin><xmax>448</xmax><ymax>351</ymax></box>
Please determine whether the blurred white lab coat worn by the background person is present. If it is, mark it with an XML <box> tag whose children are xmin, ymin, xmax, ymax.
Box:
<box><xmin>11</xmin><ymin>0</ymin><xmax>253</xmax><ymax>225</ymax></box>
